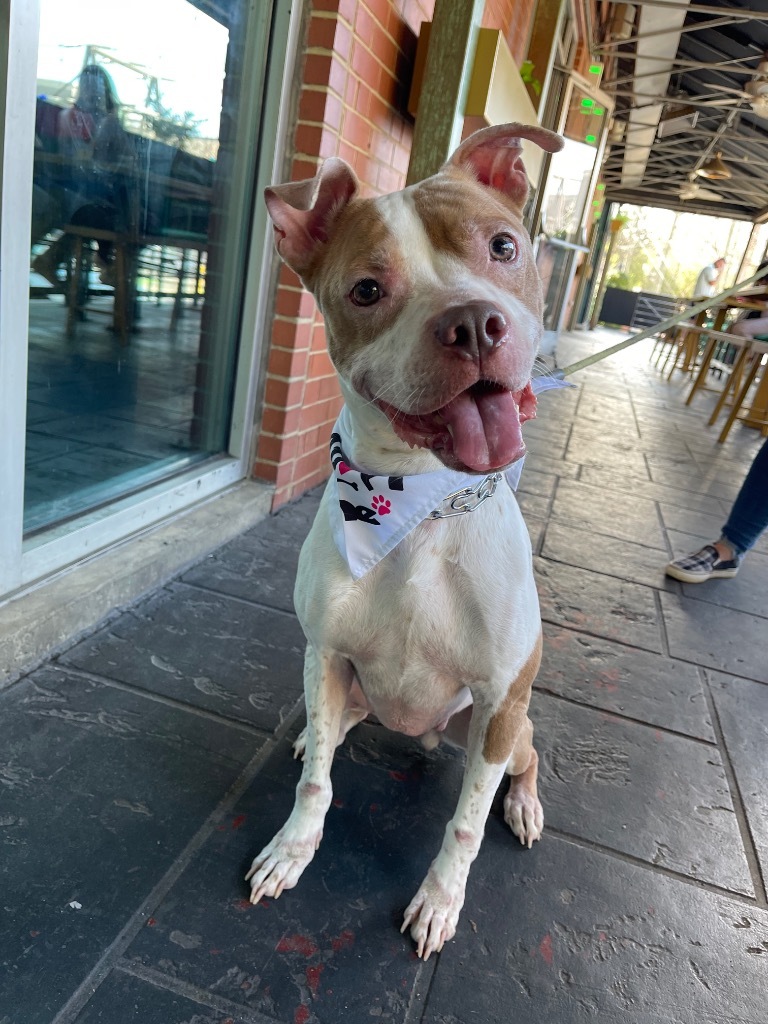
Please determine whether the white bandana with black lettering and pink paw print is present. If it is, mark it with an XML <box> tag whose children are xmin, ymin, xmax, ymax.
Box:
<box><xmin>331</xmin><ymin>377</ymin><xmax>573</xmax><ymax>580</ymax></box>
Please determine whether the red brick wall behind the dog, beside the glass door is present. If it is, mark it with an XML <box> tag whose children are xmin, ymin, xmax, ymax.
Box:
<box><xmin>254</xmin><ymin>0</ymin><xmax>535</xmax><ymax>508</ymax></box>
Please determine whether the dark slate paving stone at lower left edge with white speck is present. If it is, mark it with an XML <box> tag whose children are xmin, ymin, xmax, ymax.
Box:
<box><xmin>0</xmin><ymin>669</ymin><xmax>259</xmax><ymax>1024</ymax></box>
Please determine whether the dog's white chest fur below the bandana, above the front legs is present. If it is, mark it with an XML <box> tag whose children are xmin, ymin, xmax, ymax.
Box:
<box><xmin>295</xmin><ymin>479</ymin><xmax>541</xmax><ymax>735</ymax></box>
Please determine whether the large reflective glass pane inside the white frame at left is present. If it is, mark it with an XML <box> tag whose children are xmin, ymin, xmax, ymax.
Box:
<box><xmin>25</xmin><ymin>0</ymin><xmax>255</xmax><ymax>535</ymax></box>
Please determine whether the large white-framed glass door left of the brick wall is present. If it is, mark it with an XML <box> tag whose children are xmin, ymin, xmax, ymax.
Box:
<box><xmin>0</xmin><ymin>0</ymin><xmax>294</xmax><ymax>598</ymax></box>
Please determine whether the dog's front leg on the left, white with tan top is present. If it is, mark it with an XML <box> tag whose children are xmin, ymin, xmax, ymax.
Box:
<box><xmin>246</xmin><ymin>645</ymin><xmax>353</xmax><ymax>903</ymax></box>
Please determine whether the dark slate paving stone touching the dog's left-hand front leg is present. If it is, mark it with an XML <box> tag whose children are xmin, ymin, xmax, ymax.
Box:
<box><xmin>62</xmin><ymin>584</ymin><xmax>305</xmax><ymax>731</ymax></box>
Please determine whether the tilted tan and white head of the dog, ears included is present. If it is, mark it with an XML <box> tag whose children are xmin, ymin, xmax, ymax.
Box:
<box><xmin>265</xmin><ymin>124</ymin><xmax>562</xmax><ymax>473</ymax></box>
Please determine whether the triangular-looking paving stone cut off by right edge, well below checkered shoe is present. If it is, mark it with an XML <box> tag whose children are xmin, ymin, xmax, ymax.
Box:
<box><xmin>708</xmin><ymin>672</ymin><xmax>768</xmax><ymax>879</ymax></box>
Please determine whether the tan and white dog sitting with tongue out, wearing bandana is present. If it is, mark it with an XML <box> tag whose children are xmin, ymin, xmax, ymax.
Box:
<box><xmin>246</xmin><ymin>124</ymin><xmax>562</xmax><ymax>959</ymax></box>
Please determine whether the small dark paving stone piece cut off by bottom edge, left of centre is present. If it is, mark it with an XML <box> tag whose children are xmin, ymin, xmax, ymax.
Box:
<box><xmin>74</xmin><ymin>971</ymin><xmax>241</xmax><ymax>1024</ymax></box>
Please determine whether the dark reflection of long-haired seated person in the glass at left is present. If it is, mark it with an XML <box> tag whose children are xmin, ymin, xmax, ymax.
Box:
<box><xmin>32</xmin><ymin>65</ymin><xmax>135</xmax><ymax>285</ymax></box>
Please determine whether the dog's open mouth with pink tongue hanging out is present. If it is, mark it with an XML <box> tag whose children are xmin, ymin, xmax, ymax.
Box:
<box><xmin>376</xmin><ymin>380</ymin><xmax>536</xmax><ymax>473</ymax></box>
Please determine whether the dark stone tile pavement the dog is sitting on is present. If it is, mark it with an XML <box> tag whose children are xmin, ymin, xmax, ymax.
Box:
<box><xmin>0</xmin><ymin>331</ymin><xmax>768</xmax><ymax>1024</ymax></box>
